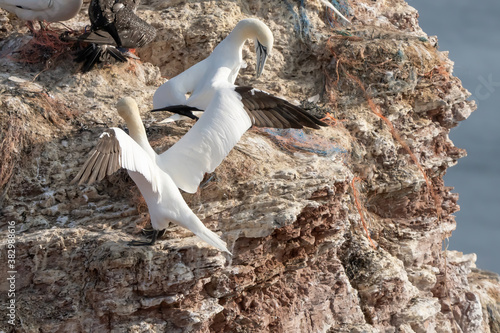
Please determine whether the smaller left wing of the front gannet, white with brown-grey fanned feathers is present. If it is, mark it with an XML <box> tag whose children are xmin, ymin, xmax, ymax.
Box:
<box><xmin>71</xmin><ymin>127</ymin><xmax>161</xmax><ymax>200</ymax></box>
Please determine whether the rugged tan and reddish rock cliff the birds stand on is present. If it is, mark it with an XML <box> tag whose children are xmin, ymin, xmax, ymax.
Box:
<box><xmin>0</xmin><ymin>0</ymin><xmax>500</xmax><ymax>332</ymax></box>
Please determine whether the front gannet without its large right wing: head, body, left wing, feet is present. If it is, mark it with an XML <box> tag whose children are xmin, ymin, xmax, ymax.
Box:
<box><xmin>71</xmin><ymin>97</ymin><xmax>230</xmax><ymax>253</ymax></box>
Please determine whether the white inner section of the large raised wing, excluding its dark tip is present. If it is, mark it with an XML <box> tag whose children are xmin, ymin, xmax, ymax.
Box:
<box><xmin>158</xmin><ymin>86</ymin><xmax>252</xmax><ymax>193</ymax></box>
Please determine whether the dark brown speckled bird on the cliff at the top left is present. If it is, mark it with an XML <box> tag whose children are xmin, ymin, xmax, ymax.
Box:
<box><xmin>71</xmin><ymin>0</ymin><xmax>156</xmax><ymax>72</ymax></box>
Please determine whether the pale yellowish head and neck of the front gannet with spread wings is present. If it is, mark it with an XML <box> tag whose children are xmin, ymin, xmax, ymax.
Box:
<box><xmin>116</xmin><ymin>97</ymin><xmax>156</xmax><ymax>160</ymax></box>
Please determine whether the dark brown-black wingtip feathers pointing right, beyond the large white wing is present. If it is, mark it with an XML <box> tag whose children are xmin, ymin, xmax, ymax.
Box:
<box><xmin>235</xmin><ymin>87</ymin><xmax>327</xmax><ymax>129</ymax></box>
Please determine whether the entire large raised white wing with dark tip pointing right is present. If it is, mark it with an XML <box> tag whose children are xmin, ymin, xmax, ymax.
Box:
<box><xmin>158</xmin><ymin>85</ymin><xmax>327</xmax><ymax>193</ymax></box>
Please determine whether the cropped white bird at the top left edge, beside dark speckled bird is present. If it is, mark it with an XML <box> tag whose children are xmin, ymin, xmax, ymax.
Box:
<box><xmin>0</xmin><ymin>0</ymin><xmax>83</xmax><ymax>26</ymax></box>
